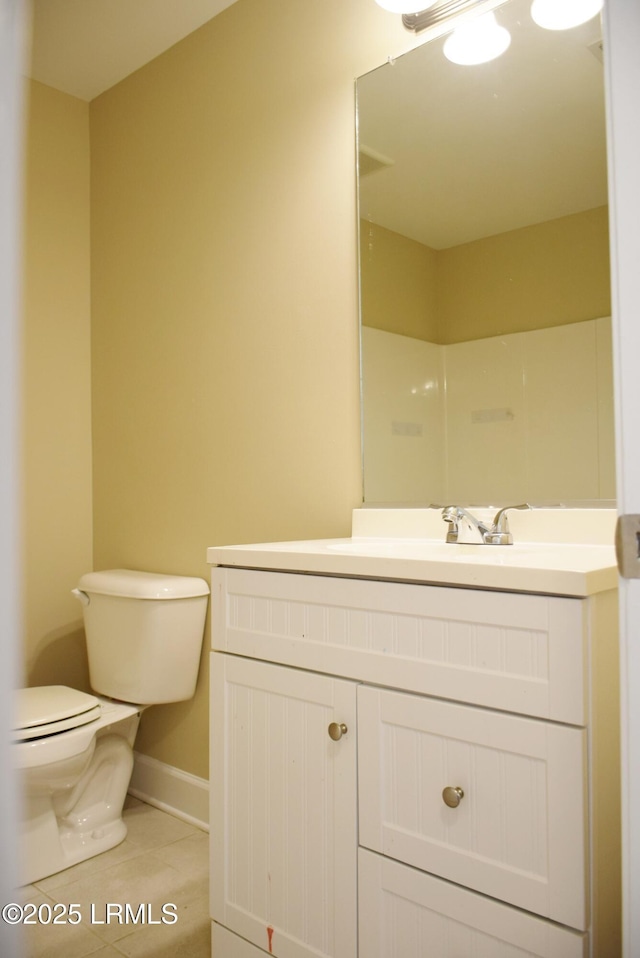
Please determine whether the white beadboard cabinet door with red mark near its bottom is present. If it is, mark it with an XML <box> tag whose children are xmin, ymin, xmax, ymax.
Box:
<box><xmin>210</xmin><ymin>653</ymin><xmax>357</xmax><ymax>958</ymax></box>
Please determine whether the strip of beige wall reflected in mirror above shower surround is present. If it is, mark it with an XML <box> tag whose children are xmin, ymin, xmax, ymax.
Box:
<box><xmin>360</xmin><ymin>206</ymin><xmax>611</xmax><ymax>344</ymax></box>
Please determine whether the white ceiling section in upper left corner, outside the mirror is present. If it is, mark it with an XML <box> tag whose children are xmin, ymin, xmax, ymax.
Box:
<box><xmin>28</xmin><ymin>0</ymin><xmax>236</xmax><ymax>100</ymax></box>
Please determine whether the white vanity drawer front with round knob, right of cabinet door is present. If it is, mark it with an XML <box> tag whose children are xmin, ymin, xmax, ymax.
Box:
<box><xmin>358</xmin><ymin>688</ymin><xmax>587</xmax><ymax>929</ymax></box>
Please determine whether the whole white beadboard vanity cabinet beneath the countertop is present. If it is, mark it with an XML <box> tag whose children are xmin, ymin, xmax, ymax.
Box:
<box><xmin>211</xmin><ymin>567</ymin><xmax>620</xmax><ymax>958</ymax></box>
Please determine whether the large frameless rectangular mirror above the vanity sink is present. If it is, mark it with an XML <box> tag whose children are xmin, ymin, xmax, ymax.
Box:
<box><xmin>357</xmin><ymin>0</ymin><xmax>615</xmax><ymax>505</ymax></box>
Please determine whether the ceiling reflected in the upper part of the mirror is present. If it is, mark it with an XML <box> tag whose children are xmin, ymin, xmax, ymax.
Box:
<box><xmin>358</xmin><ymin>2</ymin><xmax>607</xmax><ymax>249</ymax></box>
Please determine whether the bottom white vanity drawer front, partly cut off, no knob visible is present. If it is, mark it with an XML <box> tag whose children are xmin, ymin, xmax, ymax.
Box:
<box><xmin>358</xmin><ymin>849</ymin><xmax>587</xmax><ymax>958</ymax></box>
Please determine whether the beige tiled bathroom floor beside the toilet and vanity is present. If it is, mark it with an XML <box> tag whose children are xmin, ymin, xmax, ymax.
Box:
<box><xmin>20</xmin><ymin>797</ymin><xmax>211</xmax><ymax>958</ymax></box>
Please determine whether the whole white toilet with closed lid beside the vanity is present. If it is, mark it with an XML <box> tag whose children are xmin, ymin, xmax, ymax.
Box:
<box><xmin>11</xmin><ymin>569</ymin><xmax>209</xmax><ymax>885</ymax></box>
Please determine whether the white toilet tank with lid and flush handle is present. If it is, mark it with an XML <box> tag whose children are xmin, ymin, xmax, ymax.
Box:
<box><xmin>74</xmin><ymin>569</ymin><xmax>209</xmax><ymax>705</ymax></box>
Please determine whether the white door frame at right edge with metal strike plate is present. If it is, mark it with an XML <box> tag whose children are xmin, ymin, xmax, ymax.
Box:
<box><xmin>604</xmin><ymin>0</ymin><xmax>640</xmax><ymax>958</ymax></box>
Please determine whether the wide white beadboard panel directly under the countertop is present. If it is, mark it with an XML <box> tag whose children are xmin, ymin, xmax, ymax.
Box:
<box><xmin>212</xmin><ymin>568</ymin><xmax>586</xmax><ymax>725</ymax></box>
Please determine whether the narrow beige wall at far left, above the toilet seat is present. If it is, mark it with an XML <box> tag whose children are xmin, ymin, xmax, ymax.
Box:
<box><xmin>21</xmin><ymin>82</ymin><xmax>92</xmax><ymax>688</ymax></box>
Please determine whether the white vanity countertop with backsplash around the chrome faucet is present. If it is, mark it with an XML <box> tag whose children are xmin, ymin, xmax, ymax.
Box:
<box><xmin>207</xmin><ymin>510</ymin><xmax>618</xmax><ymax>596</ymax></box>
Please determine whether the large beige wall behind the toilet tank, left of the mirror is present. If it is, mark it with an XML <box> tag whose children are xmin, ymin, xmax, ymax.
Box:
<box><xmin>91</xmin><ymin>0</ymin><xmax>422</xmax><ymax>776</ymax></box>
